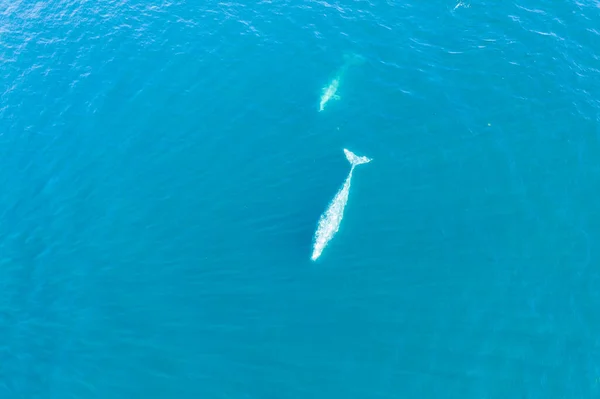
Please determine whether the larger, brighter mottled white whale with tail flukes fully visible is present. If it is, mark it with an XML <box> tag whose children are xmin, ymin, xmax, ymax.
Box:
<box><xmin>310</xmin><ymin>148</ymin><xmax>371</xmax><ymax>261</ymax></box>
